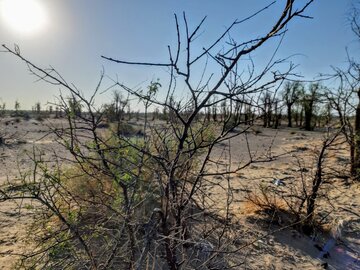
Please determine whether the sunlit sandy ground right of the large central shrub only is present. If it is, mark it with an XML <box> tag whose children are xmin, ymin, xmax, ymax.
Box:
<box><xmin>209</xmin><ymin>128</ymin><xmax>360</xmax><ymax>269</ymax></box>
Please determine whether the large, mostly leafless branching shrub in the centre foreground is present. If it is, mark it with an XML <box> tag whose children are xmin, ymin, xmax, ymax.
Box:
<box><xmin>1</xmin><ymin>0</ymin><xmax>313</xmax><ymax>269</ymax></box>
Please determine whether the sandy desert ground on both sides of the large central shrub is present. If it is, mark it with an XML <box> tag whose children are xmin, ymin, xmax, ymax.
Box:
<box><xmin>0</xmin><ymin>119</ymin><xmax>360</xmax><ymax>269</ymax></box>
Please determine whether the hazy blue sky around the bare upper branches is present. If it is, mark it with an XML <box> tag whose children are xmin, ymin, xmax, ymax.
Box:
<box><xmin>0</xmin><ymin>0</ymin><xmax>360</xmax><ymax>109</ymax></box>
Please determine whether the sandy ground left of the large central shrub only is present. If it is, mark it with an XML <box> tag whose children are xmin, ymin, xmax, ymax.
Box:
<box><xmin>0</xmin><ymin>118</ymin><xmax>66</xmax><ymax>269</ymax></box>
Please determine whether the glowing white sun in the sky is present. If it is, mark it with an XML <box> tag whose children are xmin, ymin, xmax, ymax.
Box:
<box><xmin>0</xmin><ymin>0</ymin><xmax>47</xmax><ymax>35</ymax></box>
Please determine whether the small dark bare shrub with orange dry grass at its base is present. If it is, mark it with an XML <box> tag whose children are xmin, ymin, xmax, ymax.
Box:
<box><xmin>248</xmin><ymin>129</ymin><xmax>343</xmax><ymax>235</ymax></box>
